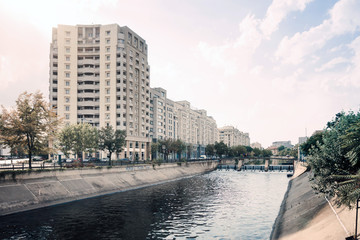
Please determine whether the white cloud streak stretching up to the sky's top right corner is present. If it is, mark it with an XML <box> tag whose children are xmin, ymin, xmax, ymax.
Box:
<box><xmin>275</xmin><ymin>0</ymin><xmax>360</xmax><ymax>65</ymax></box>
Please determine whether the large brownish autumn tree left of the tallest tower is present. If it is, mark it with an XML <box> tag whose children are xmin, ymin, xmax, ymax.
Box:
<box><xmin>0</xmin><ymin>92</ymin><xmax>59</xmax><ymax>169</ymax></box>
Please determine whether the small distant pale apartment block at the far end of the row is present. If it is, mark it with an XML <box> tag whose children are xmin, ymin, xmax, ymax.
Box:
<box><xmin>219</xmin><ymin>126</ymin><xmax>250</xmax><ymax>147</ymax></box>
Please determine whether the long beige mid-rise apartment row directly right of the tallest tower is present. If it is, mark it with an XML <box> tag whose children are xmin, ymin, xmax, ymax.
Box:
<box><xmin>150</xmin><ymin>88</ymin><xmax>218</xmax><ymax>157</ymax></box>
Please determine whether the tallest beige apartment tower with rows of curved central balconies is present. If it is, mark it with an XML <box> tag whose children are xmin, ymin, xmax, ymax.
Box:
<box><xmin>50</xmin><ymin>24</ymin><xmax>151</xmax><ymax>159</ymax></box>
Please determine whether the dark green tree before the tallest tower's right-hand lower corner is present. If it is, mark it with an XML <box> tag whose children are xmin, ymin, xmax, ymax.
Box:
<box><xmin>99</xmin><ymin>126</ymin><xmax>126</xmax><ymax>166</ymax></box>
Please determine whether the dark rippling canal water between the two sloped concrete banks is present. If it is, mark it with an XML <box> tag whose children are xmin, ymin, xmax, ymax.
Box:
<box><xmin>0</xmin><ymin>170</ymin><xmax>288</xmax><ymax>240</ymax></box>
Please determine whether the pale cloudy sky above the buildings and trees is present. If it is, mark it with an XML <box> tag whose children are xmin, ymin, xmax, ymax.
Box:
<box><xmin>0</xmin><ymin>0</ymin><xmax>360</xmax><ymax>147</ymax></box>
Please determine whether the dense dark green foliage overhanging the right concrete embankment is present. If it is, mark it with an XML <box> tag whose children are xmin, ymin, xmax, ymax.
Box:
<box><xmin>309</xmin><ymin>112</ymin><xmax>360</xmax><ymax>207</ymax></box>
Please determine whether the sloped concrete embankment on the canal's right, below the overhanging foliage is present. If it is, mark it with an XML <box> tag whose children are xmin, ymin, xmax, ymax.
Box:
<box><xmin>271</xmin><ymin>163</ymin><xmax>355</xmax><ymax>240</ymax></box>
